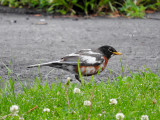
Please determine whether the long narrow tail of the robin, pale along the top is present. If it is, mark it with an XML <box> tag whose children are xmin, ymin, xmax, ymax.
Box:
<box><xmin>27</xmin><ymin>61</ymin><xmax>61</xmax><ymax>68</ymax></box>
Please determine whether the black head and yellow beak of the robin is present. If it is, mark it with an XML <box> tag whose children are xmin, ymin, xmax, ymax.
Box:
<box><xmin>98</xmin><ymin>45</ymin><xmax>122</xmax><ymax>59</ymax></box>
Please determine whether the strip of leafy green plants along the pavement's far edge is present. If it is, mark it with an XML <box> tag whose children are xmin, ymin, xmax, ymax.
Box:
<box><xmin>0</xmin><ymin>0</ymin><xmax>160</xmax><ymax>18</ymax></box>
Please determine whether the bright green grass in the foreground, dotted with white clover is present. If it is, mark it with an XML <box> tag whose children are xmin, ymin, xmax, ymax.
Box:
<box><xmin>0</xmin><ymin>69</ymin><xmax>160</xmax><ymax>120</ymax></box>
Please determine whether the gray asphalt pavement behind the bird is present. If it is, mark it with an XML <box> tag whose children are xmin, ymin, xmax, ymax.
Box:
<box><xmin>0</xmin><ymin>13</ymin><xmax>160</xmax><ymax>86</ymax></box>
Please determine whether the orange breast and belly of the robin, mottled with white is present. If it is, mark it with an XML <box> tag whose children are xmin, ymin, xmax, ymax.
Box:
<box><xmin>76</xmin><ymin>57</ymin><xmax>108</xmax><ymax>76</ymax></box>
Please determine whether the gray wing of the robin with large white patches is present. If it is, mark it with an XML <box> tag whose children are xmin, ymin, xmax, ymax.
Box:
<box><xmin>61</xmin><ymin>49</ymin><xmax>104</xmax><ymax>66</ymax></box>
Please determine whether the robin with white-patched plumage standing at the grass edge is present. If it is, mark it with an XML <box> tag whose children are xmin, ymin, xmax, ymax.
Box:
<box><xmin>28</xmin><ymin>45</ymin><xmax>122</xmax><ymax>82</ymax></box>
